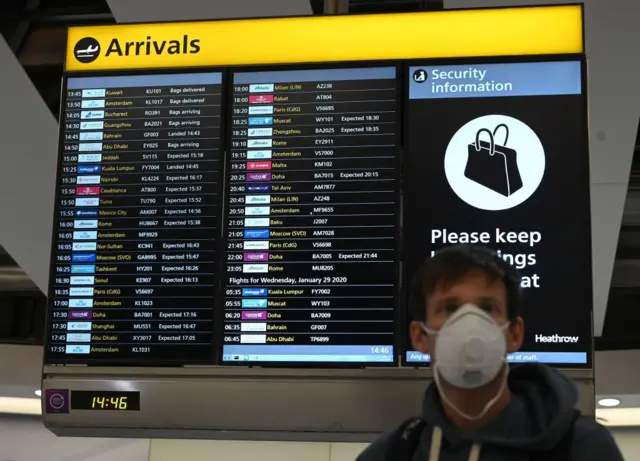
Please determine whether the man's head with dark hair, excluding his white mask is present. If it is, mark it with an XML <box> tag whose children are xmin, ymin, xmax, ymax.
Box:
<box><xmin>409</xmin><ymin>245</ymin><xmax>524</xmax><ymax>360</ymax></box>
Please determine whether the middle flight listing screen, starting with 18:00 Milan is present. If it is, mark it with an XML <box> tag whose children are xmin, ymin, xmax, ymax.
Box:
<box><xmin>222</xmin><ymin>67</ymin><xmax>399</xmax><ymax>366</ymax></box>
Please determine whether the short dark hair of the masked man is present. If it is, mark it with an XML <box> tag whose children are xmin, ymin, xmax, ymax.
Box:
<box><xmin>408</xmin><ymin>244</ymin><xmax>523</xmax><ymax>322</ymax></box>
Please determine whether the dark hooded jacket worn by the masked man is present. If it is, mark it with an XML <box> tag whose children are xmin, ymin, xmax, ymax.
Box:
<box><xmin>357</xmin><ymin>364</ymin><xmax>624</xmax><ymax>461</ymax></box>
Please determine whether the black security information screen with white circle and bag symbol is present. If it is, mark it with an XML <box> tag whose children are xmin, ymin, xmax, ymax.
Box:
<box><xmin>404</xmin><ymin>61</ymin><xmax>592</xmax><ymax>367</ymax></box>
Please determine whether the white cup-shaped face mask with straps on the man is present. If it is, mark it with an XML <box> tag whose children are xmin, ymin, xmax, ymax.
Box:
<box><xmin>422</xmin><ymin>304</ymin><xmax>509</xmax><ymax>420</ymax></box>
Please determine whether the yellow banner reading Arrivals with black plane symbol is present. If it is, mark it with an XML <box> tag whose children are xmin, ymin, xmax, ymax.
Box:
<box><xmin>66</xmin><ymin>5</ymin><xmax>584</xmax><ymax>72</ymax></box>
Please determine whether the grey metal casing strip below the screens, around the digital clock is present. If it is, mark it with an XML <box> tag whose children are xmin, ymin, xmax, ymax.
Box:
<box><xmin>43</xmin><ymin>366</ymin><xmax>595</xmax><ymax>442</ymax></box>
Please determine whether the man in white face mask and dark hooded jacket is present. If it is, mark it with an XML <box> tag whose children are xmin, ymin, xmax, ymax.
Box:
<box><xmin>358</xmin><ymin>245</ymin><xmax>623</xmax><ymax>461</ymax></box>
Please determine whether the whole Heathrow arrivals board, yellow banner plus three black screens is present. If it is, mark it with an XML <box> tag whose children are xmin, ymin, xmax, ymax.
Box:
<box><xmin>45</xmin><ymin>5</ymin><xmax>592</xmax><ymax>368</ymax></box>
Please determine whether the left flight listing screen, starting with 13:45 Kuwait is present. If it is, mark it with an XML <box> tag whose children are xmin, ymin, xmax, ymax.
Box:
<box><xmin>46</xmin><ymin>72</ymin><xmax>222</xmax><ymax>364</ymax></box>
